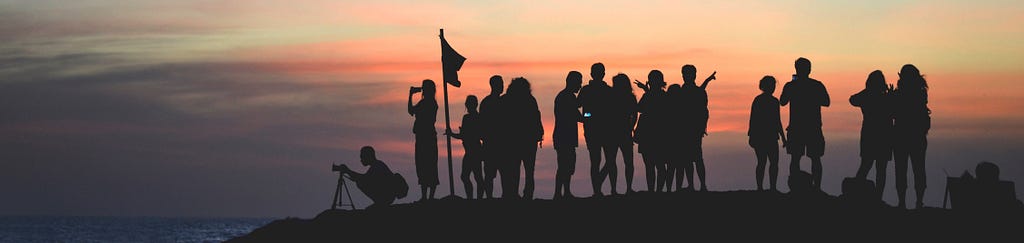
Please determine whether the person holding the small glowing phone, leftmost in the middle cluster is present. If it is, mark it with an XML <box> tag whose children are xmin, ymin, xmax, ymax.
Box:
<box><xmin>552</xmin><ymin>71</ymin><xmax>583</xmax><ymax>199</ymax></box>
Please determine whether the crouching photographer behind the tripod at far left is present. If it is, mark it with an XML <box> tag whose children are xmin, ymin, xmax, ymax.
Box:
<box><xmin>338</xmin><ymin>146</ymin><xmax>409</xmax><ymax>209</ymax></box>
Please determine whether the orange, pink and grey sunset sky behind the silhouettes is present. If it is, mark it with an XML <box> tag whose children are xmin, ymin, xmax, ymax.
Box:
<box><xmin>6</xmin><ymin>0</ymin><xmax>1024</xmax><ymax>217</ymax></box>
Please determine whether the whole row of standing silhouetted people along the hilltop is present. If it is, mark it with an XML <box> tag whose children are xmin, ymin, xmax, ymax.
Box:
<box><xmin>399</xmin><ymin>57</ymin><xmax>930</xmax><ymax>207</ymax></box>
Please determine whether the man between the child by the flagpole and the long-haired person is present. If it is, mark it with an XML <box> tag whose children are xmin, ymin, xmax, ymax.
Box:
<box><xmin>480</xmin><ymin>75</ymin><xmax>508</xmax><ymax>198</ymax></box>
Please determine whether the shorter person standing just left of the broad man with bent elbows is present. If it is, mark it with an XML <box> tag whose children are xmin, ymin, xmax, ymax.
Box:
<box><xmin>746</xmin><ymin>76</ymin><xmax>786</xmax><ymax>192</ymax></box>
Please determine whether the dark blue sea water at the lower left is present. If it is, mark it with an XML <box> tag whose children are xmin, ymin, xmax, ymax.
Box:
<box><xmin>0</xmin><ymin>216</ymin><xmax>273</xmax><ymax>242</ymax></box>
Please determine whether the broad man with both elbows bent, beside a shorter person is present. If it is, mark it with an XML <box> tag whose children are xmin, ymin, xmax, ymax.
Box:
<box><xmin>779</xmin><ymin>57</ymin><xmax>831</xmax><ymax>191</ymax></box>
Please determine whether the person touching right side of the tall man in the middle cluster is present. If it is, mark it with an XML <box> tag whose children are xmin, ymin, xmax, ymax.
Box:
<box><xmin>603</xmin><ymin>74</ymin><xmax>637</xmax><ymax>194</ymax></box>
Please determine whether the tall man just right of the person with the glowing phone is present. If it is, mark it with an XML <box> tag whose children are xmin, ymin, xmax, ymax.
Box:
<box><xmin>578</xmin><ymin>63</ymin><xmax>611</xmax><ymax>197</ymax></box>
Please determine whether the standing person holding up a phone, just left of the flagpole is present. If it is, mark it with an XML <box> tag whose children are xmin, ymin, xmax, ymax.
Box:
<box><xmin>409</xmin><ymin>79</ymin><xmax>439</xmax><ymax>201</ymax></box>
